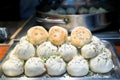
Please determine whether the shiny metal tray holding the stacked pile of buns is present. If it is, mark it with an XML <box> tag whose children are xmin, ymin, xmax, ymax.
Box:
<box><xmin>0</xmin><ymin>40</ymin><xmax>120</xmax><ymax>80</ymax></box>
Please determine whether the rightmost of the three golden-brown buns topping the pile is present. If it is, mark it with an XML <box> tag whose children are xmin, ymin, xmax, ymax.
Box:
<box><xmin>70</xmin><ymin>26</ymin><xmax>92</xmax><ymax>48</ymax></box>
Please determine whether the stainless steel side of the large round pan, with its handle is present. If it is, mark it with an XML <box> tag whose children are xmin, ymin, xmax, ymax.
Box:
<box><xmin>36</xmin><ymin>11</ymin><xmax>111</xmax><ymax>32</ymax></box>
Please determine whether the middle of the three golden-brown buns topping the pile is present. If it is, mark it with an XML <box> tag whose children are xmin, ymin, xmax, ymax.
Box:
<box><xmin>49</xmin><ymin>26</ymin><xmax>68</xmax><ymax>45</ymax></box>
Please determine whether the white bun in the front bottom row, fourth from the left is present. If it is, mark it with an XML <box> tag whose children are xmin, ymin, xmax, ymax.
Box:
<box><xmin>67</xmin><ymin>56</ymin><xmax>89</xmax><ymax>76</ymax></box>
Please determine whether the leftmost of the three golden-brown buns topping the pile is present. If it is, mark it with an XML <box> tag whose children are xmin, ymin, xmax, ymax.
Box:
<box><xmin>27</xmin><ymin>26</ymin><xmax>48</xmax><ymax>45</ymax></box>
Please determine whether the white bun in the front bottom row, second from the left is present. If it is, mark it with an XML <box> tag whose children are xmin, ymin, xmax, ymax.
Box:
<box><xmin>25</xmin><ymin>57</ymin><xmax>46</xmax><ymax>77</ymax></box>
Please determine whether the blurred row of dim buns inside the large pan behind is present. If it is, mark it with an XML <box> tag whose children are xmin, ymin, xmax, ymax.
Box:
<box><xmin>47</xmin><ymin>7</ymin><xmax>107</xmax><ymax>15</ymax></box>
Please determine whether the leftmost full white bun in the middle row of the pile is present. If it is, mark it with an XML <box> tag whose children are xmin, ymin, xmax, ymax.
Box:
<box><xmin>15</xmin><ymin>41</ymin><xmax>35</xmax><ymax>60</ymax></box>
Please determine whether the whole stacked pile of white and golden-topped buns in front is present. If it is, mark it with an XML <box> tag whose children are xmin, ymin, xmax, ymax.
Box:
<box><xmin>2</xmin><ymin>26</ymin><xmax>114</xmax><ymax>77</ymax></box>
